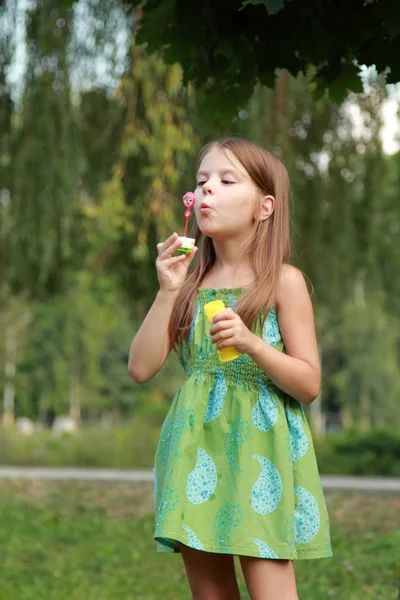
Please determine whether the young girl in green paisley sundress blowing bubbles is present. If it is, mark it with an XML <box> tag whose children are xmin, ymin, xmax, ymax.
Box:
<box><xmin>129</xmin><ymin>138</ymin><xmax>332</xmax><ymax>600</ymax></box>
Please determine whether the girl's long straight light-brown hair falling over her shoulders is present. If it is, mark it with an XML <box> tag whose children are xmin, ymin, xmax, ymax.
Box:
<box><xmin>169</xmin><ymin>138</ymin><xmax>290</xmax><ymax>350</ymax></box>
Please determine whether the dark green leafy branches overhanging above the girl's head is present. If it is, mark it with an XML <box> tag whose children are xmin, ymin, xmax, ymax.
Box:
<box><xmin>122</xmin><ymin>0</ymin><xmax>400</xmax><ymax>123</ymax></box>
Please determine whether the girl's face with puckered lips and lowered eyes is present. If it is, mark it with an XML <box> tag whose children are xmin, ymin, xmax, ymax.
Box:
<box><xmin>194</xmin><ymin>147</ymin><xmax>260</xmax><ymax>240</ymax></box>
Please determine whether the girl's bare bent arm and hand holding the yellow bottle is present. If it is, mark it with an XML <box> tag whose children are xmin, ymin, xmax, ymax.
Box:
<box><xmin>210</xmin><ymin>266</ymin><xmax>321</xmax><ymax>404</ymax></box>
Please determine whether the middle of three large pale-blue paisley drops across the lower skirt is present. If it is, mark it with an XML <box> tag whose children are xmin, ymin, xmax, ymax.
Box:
<box><xmin>251</xmin><ymin>455</ymin><xmax>282</xmax><ymax>515</ymax></box>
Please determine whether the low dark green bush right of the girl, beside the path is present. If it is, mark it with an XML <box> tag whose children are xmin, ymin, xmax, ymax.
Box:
<box><xmin>315</xmin><ymin>428</ymin><xmax>400</xmax><ymax>477</ymax></box>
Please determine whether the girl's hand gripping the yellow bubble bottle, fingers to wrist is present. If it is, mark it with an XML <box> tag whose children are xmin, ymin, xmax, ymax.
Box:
<box><xmin>210</xmin><ymin>308</ymin><xmax>256</xmax><ymax>354</ymax></box>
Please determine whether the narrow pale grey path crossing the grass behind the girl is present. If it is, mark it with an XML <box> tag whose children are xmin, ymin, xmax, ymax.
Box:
<box><xmin>0</xmin><ymin>467</ymin><xmax>400</xmax><ymax>494</ymax></box>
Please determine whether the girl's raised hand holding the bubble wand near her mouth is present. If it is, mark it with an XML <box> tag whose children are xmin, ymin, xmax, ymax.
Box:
<box><xmin>156</xmin><ymin>233</ymin><xmax>197</xmax><ymax>292</ymax></box>
